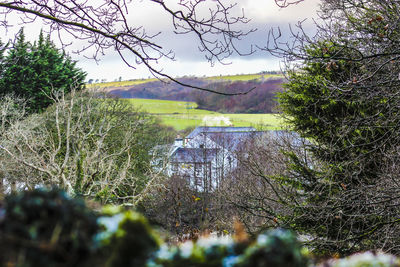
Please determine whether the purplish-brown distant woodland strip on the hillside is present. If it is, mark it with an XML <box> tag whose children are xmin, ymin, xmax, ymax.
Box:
<box><xmin>110</xmin><ymin>77</ymin><xmax>285</xmax><ymax>113</ymax></box>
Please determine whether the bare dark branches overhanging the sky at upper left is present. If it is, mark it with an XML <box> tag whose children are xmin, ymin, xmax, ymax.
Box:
<box><xmin>0</xmin><ymin>0</ymin><xmax>260</xmax><ymax>95</ymax></box>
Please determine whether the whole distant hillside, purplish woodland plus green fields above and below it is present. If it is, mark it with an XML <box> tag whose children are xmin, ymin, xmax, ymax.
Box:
<box><xmin>87</xmin><ymin>74</ymin><xmax>283</xmax><ymax>130</ymax></box>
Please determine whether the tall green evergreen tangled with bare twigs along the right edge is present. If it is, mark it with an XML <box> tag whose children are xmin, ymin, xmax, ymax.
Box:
<box><xmin>279</xmin><ymin>0</ymin><xmax>400</xmax><ymax>255</ymax></box>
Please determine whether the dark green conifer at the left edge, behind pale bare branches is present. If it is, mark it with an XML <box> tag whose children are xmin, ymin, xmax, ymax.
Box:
<box><xmin>0</xmin><ymin>29</ymin><xmax>86</xmax><ymax>112</ymax></box>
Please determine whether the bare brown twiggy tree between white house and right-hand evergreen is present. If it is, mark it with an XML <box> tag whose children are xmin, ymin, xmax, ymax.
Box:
<box><xmin>214</xmin><ymin>131</ymin><xmax>307</xmax><ymax>233</ymax></box>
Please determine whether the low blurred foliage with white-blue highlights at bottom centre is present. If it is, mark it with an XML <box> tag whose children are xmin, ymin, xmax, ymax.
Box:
<box><xmin>147</xmin><ymin>229</ymin><xmax>310</xmax><ymax>267</ymax></box>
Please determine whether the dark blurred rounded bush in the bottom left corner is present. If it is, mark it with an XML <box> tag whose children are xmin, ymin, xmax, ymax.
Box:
<box><xmin>0</xmin><ymin>189</ymin><xmax>99</xmax><ymax>267</ymax></box>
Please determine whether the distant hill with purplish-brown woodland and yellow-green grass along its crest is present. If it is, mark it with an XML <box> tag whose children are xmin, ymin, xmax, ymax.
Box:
<box><xmin>88</xmin><ymin>74</ymin><xmax>286</xmax><ymax>114</ymax></box>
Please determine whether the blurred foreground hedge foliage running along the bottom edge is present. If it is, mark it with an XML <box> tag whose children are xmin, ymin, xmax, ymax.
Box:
<box><xmin>0</xmin><ymin>189</ymin><xmax>400</xmax><ymax>267</ymax></box>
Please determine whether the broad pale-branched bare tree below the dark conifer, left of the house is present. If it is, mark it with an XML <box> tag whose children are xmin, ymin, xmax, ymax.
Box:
<box><xmin>0</xmin><ymin>92</ymin><xmax>170</xmax><ymax>204</ymax></box>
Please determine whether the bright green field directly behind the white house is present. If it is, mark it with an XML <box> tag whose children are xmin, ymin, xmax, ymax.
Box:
<box><xmin>126</xmin><ymin>98</ymin><xmax>283</xmax><ymax>130</ymax></box>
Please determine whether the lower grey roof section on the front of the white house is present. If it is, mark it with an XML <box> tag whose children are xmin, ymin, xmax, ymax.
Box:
<box><xmin>170</xmin><ymin>147</ymin><xmax>219</xmax><ymax>163</ymax></box>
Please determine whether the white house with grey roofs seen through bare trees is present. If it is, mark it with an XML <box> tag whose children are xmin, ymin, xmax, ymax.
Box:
<box><xmin>167</xmin><ymin>127</ymin><xmax>263</xmax><ymax>191</ymax></box>
